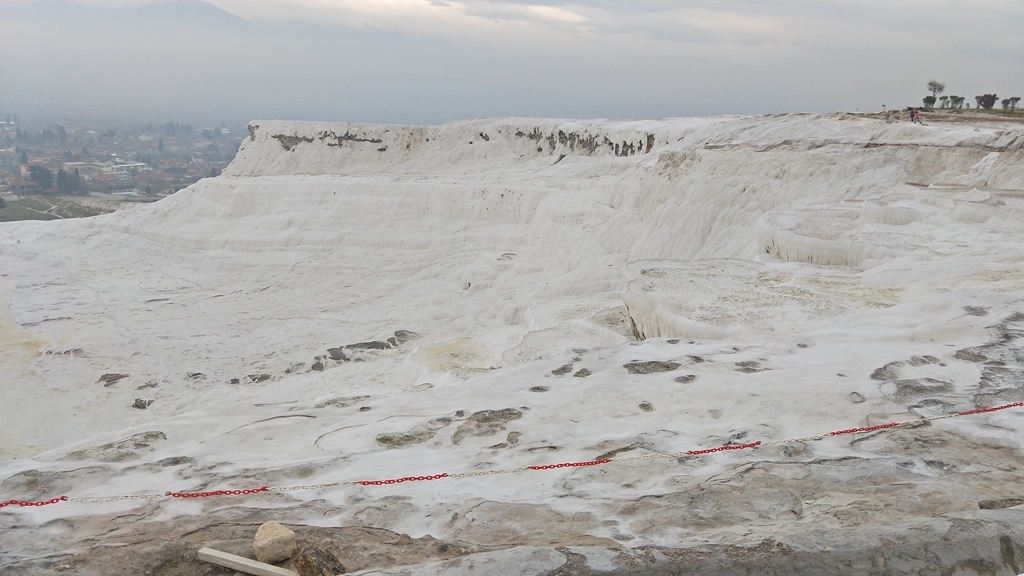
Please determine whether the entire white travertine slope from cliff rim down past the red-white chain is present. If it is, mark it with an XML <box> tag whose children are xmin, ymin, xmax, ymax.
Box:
<box><xmin>0</xmin><ymin>115</ymin><xmax>1024</xmax><ymax>566</ymax></box>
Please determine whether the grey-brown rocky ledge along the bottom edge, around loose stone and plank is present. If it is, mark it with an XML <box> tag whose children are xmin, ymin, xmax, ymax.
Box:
<box><xmin>3</xmin><ymin>501</ymin><xmax>1024</xmax><ymax>576</ymax></box>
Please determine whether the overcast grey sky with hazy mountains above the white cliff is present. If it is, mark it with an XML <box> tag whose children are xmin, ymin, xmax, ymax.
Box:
<box><xmin>0</xmin><ymin>0</ymin><xmax>1024</xmax><ymax>123</ymax></box>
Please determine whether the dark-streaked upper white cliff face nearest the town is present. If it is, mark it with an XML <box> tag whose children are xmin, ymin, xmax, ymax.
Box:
<box><xmin>226</xmin><ymin>119</ymin><xmax>669</xmax><ymax>175</ymax></box>
